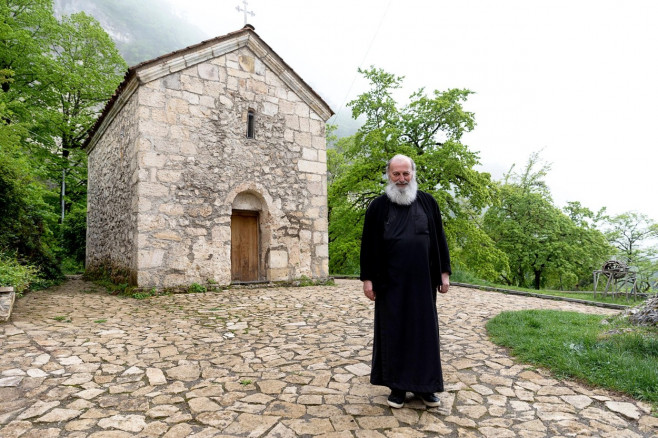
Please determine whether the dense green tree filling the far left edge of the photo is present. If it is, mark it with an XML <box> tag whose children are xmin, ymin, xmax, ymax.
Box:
<box><xmin>0</xmin><ymin>0</ymin><xmax>61</xmax><ymax>278</ymax></box>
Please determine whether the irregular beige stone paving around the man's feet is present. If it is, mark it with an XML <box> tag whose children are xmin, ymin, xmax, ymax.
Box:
<box><xmin>0</xmin><ymin>280</ymin><xmax>658</xmax><ymax>438</ymax></box>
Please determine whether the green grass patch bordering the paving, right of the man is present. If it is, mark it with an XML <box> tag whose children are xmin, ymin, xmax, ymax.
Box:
<box><xmin>486</xmin><ymin>310</ymin><xmax>658</xmax><ymax>409</ymax></box>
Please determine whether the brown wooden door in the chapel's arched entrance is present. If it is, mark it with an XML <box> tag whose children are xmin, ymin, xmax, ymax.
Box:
<box><xmin>231</xmin><ymin>210</ymin><xmax>258</xmax><ymax>281</ymax></box>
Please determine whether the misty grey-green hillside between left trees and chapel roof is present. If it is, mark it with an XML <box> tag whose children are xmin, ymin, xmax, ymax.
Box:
<box><xmin>54</xmin><ymin>0</ymin><xmax>207</xmax><ymax>66</ymax></box>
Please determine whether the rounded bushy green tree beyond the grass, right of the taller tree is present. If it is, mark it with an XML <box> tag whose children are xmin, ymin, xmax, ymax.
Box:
<box><xmin>484</xmin><ymin>153</ymin><xmax>609</xmax><ymax>289</ymax></box>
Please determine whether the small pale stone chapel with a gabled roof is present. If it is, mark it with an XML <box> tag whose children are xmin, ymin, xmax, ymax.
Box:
<box><xmin>85</xmin><ymin>25</ymin><xmax>333</xmax><ymax>288</ymax></box>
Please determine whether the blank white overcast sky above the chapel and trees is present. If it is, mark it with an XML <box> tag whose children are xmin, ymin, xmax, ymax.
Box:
<box><xmin>169</xmin><ymin>0</ymin><xmax>658</xmax><ymax>221</ymax></box>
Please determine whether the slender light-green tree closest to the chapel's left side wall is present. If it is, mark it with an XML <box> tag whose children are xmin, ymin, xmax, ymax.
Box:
<box><xmin>36</xmin><ymin>12</ymin><xmax>127</xmax><ymax>222</ymax></box>
